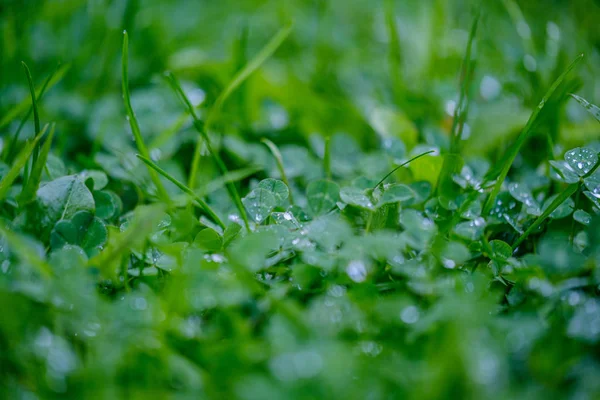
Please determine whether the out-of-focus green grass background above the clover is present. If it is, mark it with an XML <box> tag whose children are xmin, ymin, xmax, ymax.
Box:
<box><xmin>0</xmin><ymin>0</ymin><xmax>600</xmax><ymax>167</ymax></box>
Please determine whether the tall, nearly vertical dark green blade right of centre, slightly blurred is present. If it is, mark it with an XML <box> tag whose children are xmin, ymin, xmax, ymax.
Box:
<box><xmin>450</xmin><ymin>10</ymin><xmax>480</xmax><ymax>154</ymax></box>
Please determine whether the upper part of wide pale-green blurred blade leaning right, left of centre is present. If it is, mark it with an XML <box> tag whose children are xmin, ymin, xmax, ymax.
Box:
<box><xmin>206</xmin><ymin>25</ymin><xmax>292</xmax><ymax>127</ymax></box>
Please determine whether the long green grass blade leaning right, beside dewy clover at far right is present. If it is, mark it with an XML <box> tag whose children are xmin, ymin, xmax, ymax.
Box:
<box><xmin>483</xmin><ymin>54</ymin><xmax>583</xmax><ymax>213</ymax></box>
